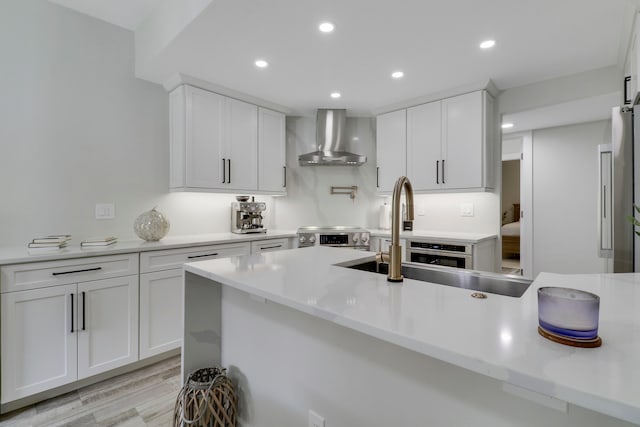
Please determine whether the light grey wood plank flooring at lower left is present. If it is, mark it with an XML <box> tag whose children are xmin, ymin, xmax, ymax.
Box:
<box><xmin>0</xmin><ymin>356</ymin><xmax>180</xmax><ymax>427</ymax></box>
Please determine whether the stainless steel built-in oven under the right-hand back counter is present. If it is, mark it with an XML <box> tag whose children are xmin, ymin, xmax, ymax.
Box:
<box><xmin>407</xmin><ymin>240</ymin><xmax>473</xmax><ymax>269</ymax></box>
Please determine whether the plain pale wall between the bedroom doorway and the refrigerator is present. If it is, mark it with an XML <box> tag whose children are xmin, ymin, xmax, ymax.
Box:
<box><xmin>533</xmin><ymin>121</ymin><xmax>611</xmax><ymax>276</ymax></box>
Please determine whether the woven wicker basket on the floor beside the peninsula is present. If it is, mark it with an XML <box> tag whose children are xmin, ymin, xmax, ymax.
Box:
<box><xmin>173</xmin><ymin>367</ymin><xmax>237</xmax><ymax>427</ymax></box>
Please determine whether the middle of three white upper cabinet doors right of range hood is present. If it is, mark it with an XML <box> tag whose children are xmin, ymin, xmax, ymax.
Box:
<box><xmin>407</xmin><ymin>101</ymin><xmax>443</xmax><ymax>191</ymax></box>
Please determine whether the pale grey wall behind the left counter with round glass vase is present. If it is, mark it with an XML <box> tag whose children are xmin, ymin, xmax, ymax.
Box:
<box><xmin>0</xmin><ymin>0</ymin><xmax>274</xmax><ymax>246</ymax></box>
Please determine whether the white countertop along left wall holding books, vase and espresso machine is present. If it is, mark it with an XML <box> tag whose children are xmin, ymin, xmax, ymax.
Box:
<box><xmin>0</xmin><ymin>230</ymin><xmax>296</xmax><ymax>265</ymax></box>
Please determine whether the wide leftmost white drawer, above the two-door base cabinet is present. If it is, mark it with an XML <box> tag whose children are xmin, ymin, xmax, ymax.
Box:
<box><xmin>0</xmin><ymin>253</ymin><xmax>138</xmax><ymax>292</ymax></box>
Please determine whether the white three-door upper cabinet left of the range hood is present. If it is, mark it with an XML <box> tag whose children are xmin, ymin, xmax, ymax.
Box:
<box><xmin>170</xmin><ymin>85</ymin><xmax>285</xmax><ymax>194</ymax></box>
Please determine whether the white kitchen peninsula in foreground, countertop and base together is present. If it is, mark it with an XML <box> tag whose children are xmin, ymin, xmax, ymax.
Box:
<box><xmin>182</xmin><ymin>247</ymin><xmax>640</xmax><ymax>426</ymax></box>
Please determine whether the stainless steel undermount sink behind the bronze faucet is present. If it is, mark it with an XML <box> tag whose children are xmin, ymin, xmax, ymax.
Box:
<box><xmin>337</xmin><ymin>258</ymin><xmax>532</xmax><ymax>298</ymax></box>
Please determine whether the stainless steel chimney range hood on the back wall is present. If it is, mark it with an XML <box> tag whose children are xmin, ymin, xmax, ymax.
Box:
<box><xmin>298</xmin><ymin>108</ymin><xmax>367</xmax><ymax>166</ymax></box>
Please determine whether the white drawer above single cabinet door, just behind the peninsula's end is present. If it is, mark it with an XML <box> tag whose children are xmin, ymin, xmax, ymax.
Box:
<box><xmin>140</xmin><ymin>242</ymin><xmax>251</xmax><ymax>273</ymax></box>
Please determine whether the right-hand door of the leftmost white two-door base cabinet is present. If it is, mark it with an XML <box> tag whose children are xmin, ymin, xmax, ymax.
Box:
<box><xmin>77</xmin><ymin>276</ymin><xmax>138</xmax><ymax>379</ymax></box>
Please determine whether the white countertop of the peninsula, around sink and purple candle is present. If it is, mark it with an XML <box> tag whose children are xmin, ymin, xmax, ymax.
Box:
<box><xmin>185</xmin><ymin>247</ymin><xmax>640</xmax><ymax>423</ymax></box>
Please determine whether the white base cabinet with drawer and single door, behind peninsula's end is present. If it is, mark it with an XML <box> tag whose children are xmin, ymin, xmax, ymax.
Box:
<box><xmin>140</xmin><ymin>242</ymin><xmax>251</xmax><ymax>359</ymax></box>
